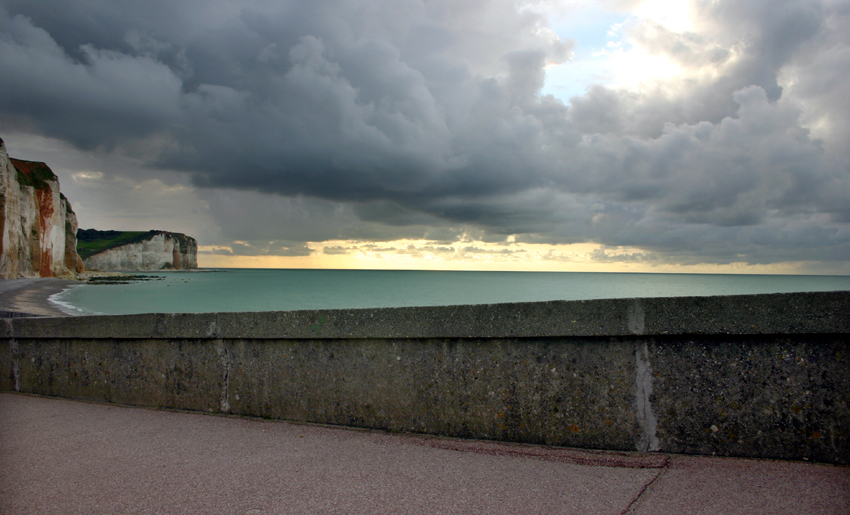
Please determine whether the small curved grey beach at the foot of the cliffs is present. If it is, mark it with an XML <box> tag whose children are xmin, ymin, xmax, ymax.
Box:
<box><xmin>0</xmin><ymin>278</ymin><xmax>83</xmax><ymax>316</ymax></box>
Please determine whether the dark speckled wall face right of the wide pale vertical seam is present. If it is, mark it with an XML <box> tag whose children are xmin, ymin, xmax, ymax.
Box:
<box><xmin>649</xmin><ymin>335</ymin><xmax>850</xmax><ymax>464</ymax></box>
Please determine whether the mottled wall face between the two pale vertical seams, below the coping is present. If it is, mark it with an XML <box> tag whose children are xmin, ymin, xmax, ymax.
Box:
<box><xmin>228</xmin><ymin>339</ymin><xmax>639</xmax><ymax>450</ymax></box>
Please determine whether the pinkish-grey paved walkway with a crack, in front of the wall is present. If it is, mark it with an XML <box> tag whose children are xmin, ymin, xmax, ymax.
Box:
<box><xmin>0</xmin><ymin>393</ymin><xmax>850</xmax><ymax>515</ymax></box>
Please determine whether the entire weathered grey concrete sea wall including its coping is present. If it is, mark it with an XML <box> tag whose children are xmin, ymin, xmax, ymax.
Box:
<box><xmin>0</xmin><ymin>292</ymin><xmax>850</xmax><ymax>465</ymax></box>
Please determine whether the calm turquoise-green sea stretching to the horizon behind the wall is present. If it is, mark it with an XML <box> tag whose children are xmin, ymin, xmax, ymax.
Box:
<box><xmin>50</xmin><ymin>269</ymin><xmax>850</xmax><ymax>315</ymax></box>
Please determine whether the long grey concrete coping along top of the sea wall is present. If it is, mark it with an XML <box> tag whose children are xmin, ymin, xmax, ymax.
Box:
<box><xmin>0</xmin><ymin>292</ymin><xmax>850</xmax><ymax>339</ymax></box>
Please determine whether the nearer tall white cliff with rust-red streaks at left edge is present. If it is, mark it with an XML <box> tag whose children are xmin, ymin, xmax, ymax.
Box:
<box><xmin>0</xmin><ymin>139</ymin><xmax>84</xmax><ymax>278</ymax></box>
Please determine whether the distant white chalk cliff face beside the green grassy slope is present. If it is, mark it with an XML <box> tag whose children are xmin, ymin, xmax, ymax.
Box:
<box><xmin>80</xmin><ymin>229</ymin><xmax>198</xmax><ymax>271</ymax></box>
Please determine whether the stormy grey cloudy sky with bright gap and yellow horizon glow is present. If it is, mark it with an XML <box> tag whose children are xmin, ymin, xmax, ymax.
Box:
<box><xmin>0</xmin><ymin>0</ymin><xmax>850</xmax><ymax>274</ymax></box>
